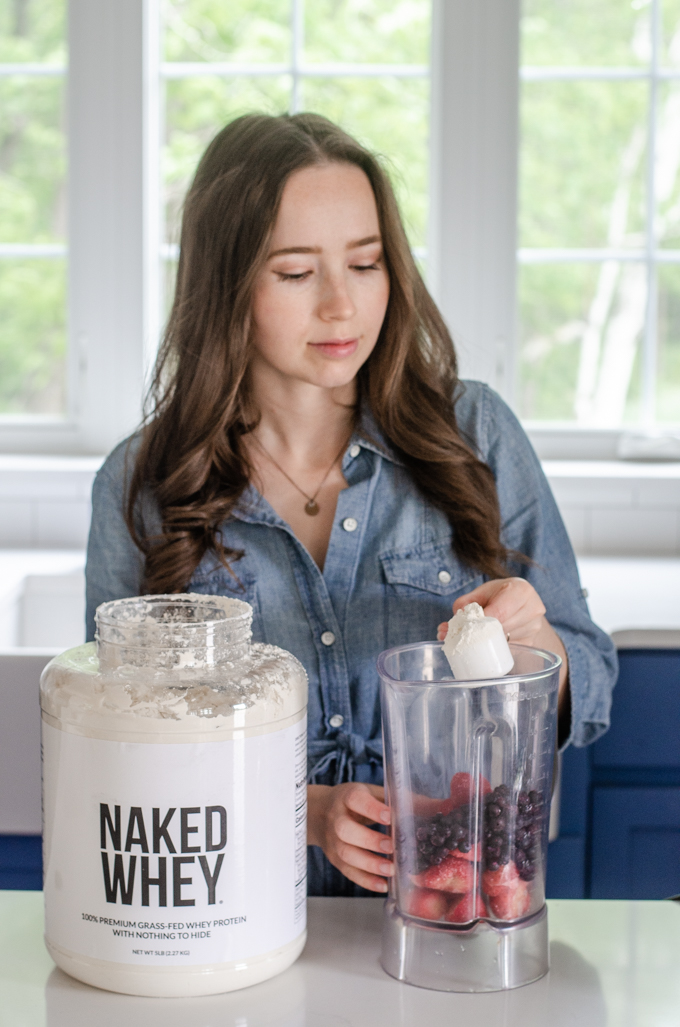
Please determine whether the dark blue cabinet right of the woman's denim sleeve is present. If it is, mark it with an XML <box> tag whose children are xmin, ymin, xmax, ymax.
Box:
<box><xmin>546</xmin><ymin>649</ymin><xmax>680</xmax><ymax>899</ymax></box>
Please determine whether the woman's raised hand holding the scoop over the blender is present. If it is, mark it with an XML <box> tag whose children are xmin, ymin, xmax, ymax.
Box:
<box><xmin>437</xmin><ymin>578</ymin><xmax>569</xmax><ymax>698</ymax></box>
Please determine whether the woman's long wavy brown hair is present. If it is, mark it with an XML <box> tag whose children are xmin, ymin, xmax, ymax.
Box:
<box><xmin>126</xmin><ymin>114</ymin><xmax>508</xmax><ymax>593</ymax></box>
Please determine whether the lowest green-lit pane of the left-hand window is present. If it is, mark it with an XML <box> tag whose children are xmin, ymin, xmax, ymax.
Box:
<box><xmin>0</xmin><ymin>260</ymin><xmax>66</xmax><ymax>415</ymax></box>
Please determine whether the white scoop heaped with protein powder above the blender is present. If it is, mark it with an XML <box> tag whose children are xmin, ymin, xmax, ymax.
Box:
<box><xmin>444</xmin><ymin>603</ymin><xmax>515</xmax><ymax>681</ymax></box>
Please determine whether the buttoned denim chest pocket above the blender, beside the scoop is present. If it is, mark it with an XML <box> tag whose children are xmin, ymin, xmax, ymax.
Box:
<box><xmin>379</xmin><ymin>539</ymin><xmax>484</xmax><ymax>647</ymax></box>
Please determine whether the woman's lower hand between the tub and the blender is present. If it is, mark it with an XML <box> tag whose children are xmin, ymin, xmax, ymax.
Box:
<box><xmin>307</xmin><ymin>782</ymin><xmax>394</xmax><ymax>891</ymax></box>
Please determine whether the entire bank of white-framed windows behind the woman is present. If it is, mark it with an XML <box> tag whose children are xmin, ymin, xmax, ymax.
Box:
<box><xmin>0</xmin><ymin>0</ymin><xmax>669</xmax><ymax>458</ymax></box>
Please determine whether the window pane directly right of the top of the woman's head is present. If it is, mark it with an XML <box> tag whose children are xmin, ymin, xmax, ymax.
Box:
<box><xmin>303</xmin><ymin>77</ymin><xmax>429</xmax><ymax>246</ymax></box>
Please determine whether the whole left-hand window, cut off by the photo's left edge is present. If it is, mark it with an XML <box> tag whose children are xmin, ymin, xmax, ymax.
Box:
<box><xmin>0</xmin><ymin>0</ymin><xmax>69</xmax><ymax>422</ymax></box>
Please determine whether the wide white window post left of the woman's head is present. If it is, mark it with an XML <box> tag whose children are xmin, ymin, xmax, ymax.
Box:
<box><xmin>69</xmin><ymin>0</ymin><xmax>158</xmax><ymax>453</ymax></box>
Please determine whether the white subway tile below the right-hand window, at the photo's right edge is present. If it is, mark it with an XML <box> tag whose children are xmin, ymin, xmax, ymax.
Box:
<box><xmin>590</xmin><ymin>506</ymin><xmax>679</xmax><ymax>557</ymax></box>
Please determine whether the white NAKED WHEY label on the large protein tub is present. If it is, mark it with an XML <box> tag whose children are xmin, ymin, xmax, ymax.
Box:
<box><xmin>42</xmin><ymin>720</ymin><xmax>307</xmax><ymax>966</ymax></box>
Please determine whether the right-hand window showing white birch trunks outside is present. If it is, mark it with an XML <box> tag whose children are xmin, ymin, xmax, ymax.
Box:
<box><xmin>516</xmin><ymin>0</ymin><xmax>680</xmax><ymax>430</ymax></box>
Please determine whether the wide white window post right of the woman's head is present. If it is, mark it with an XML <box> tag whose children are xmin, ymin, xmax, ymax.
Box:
<box><xmin>427</xmin><ymin>0</ymin><xmax>520</xmax><ymax>400</ymax></box>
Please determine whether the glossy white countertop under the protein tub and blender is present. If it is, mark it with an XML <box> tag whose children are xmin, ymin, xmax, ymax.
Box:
<box><xmin>0</xmin><ymin>891</ymin><xmax>680</xmax><ymax>1027</ymax></box>
